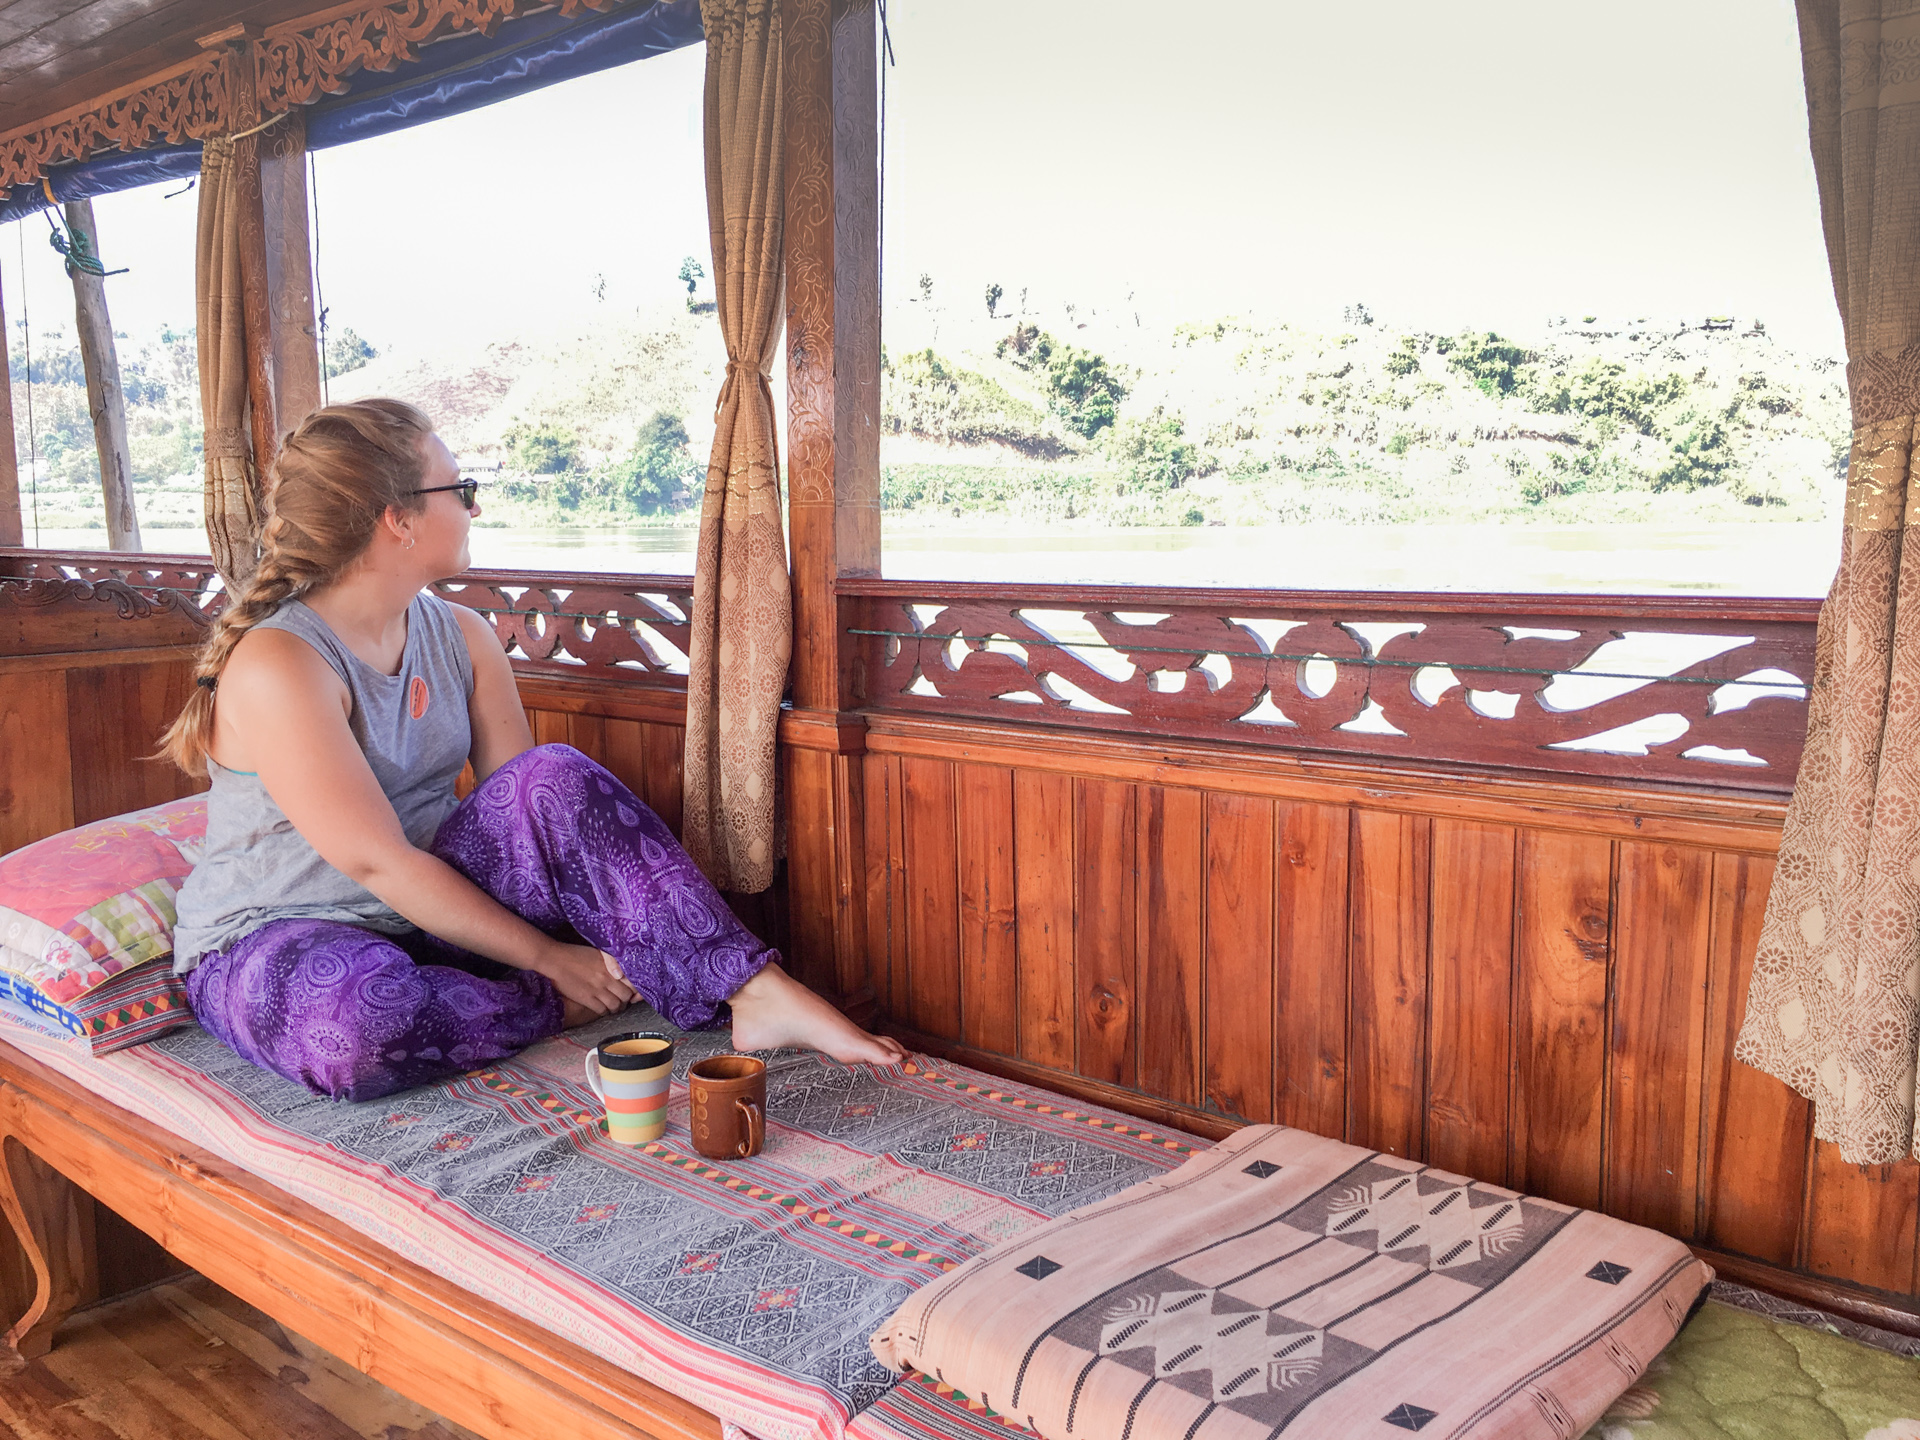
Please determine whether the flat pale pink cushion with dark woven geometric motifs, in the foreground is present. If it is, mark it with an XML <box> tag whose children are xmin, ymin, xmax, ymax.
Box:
<box><xmin>874</xmin><ymin>1125</ymin><xmax>1713</xmax><ymax>1440</ymax></box>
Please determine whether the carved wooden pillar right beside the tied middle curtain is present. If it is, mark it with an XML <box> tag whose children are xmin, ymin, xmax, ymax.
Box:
<box><xmin>781</xmin><ymin>0</ymin><xmax>879</xmax><ymax>996</ymax></box>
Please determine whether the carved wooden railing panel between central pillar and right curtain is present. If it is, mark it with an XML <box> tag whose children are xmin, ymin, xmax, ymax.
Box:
<box><xmin>839</xmin><ymin>580</ymin><xmax>1818</xmax><ymax>793</ymax></box>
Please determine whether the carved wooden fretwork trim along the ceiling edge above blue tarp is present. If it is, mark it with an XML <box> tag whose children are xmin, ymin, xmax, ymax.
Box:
<box><xmin>0</xmin><ymin>0</ymin><xmax>632</xmax><ymax>190</ymax></box>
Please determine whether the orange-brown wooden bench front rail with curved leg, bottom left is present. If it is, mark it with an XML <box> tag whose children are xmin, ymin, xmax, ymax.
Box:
<box><xmin>0</xmin><ymin>1043</ymin><xmax>720</xmax><ymax>1440</ymax></box>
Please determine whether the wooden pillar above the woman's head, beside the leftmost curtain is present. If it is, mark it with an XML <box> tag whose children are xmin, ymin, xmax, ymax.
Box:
<box><xmin>259</xmin><ymin>108</ymin><xmax>321</xmax><ymax>436</ymax></box>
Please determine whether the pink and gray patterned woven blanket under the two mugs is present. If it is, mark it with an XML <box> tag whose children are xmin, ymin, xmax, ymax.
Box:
<box><xmin>0</xmin><ymin>1012</ymin><xmax>1206</xmax><ymax>1440</ymax></box>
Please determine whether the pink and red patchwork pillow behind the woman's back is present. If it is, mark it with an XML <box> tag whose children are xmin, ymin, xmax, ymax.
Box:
<box><xmin>0</xmin><ymin>795</ymin><xmax>207</xmax><ymax>1052</ymax></box>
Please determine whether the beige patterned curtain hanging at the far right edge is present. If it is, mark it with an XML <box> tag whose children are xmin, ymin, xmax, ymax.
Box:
<box><xmin>1736</xmin><ymin>0</ymin><xmax>1920</xmax><ymax>1164</ymax></box>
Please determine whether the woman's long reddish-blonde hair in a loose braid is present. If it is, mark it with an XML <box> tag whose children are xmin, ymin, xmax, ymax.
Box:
<box><xmin>159</xmin><ymin>399</ymin><xmax>434</xmax><ymax>778</ymax></box>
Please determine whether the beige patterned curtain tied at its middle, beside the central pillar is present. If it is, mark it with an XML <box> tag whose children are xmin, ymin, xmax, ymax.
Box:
<box><xmin>684</xmin><ymin>0</ymin><xmax>793</xmax><ymax>893</ymax></box>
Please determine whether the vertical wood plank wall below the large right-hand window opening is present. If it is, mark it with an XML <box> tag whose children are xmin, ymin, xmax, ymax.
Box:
<box><xmin>864</xmin><ymin>718</ymin><xmax>1920</xmax><ymax>1320</ymax></box>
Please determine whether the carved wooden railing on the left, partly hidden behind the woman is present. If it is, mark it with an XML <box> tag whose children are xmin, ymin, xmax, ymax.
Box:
<box><xmin>0</xmin><ymin>551</ymin><xmax>693</xmax><ymax>687</ymax></box>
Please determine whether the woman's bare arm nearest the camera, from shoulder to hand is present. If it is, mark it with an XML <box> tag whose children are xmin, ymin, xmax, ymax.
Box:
<box><xmin>215</xmin><ymin>630</ymin><xmax>632</xmax><ymax>1012</ymax></box>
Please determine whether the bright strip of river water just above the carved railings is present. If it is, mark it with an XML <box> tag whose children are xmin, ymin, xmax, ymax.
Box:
<box><xmin>40</xmin><ymin>518</ymin><xmax>1839</xmax><ymax>597</ymax></box>
